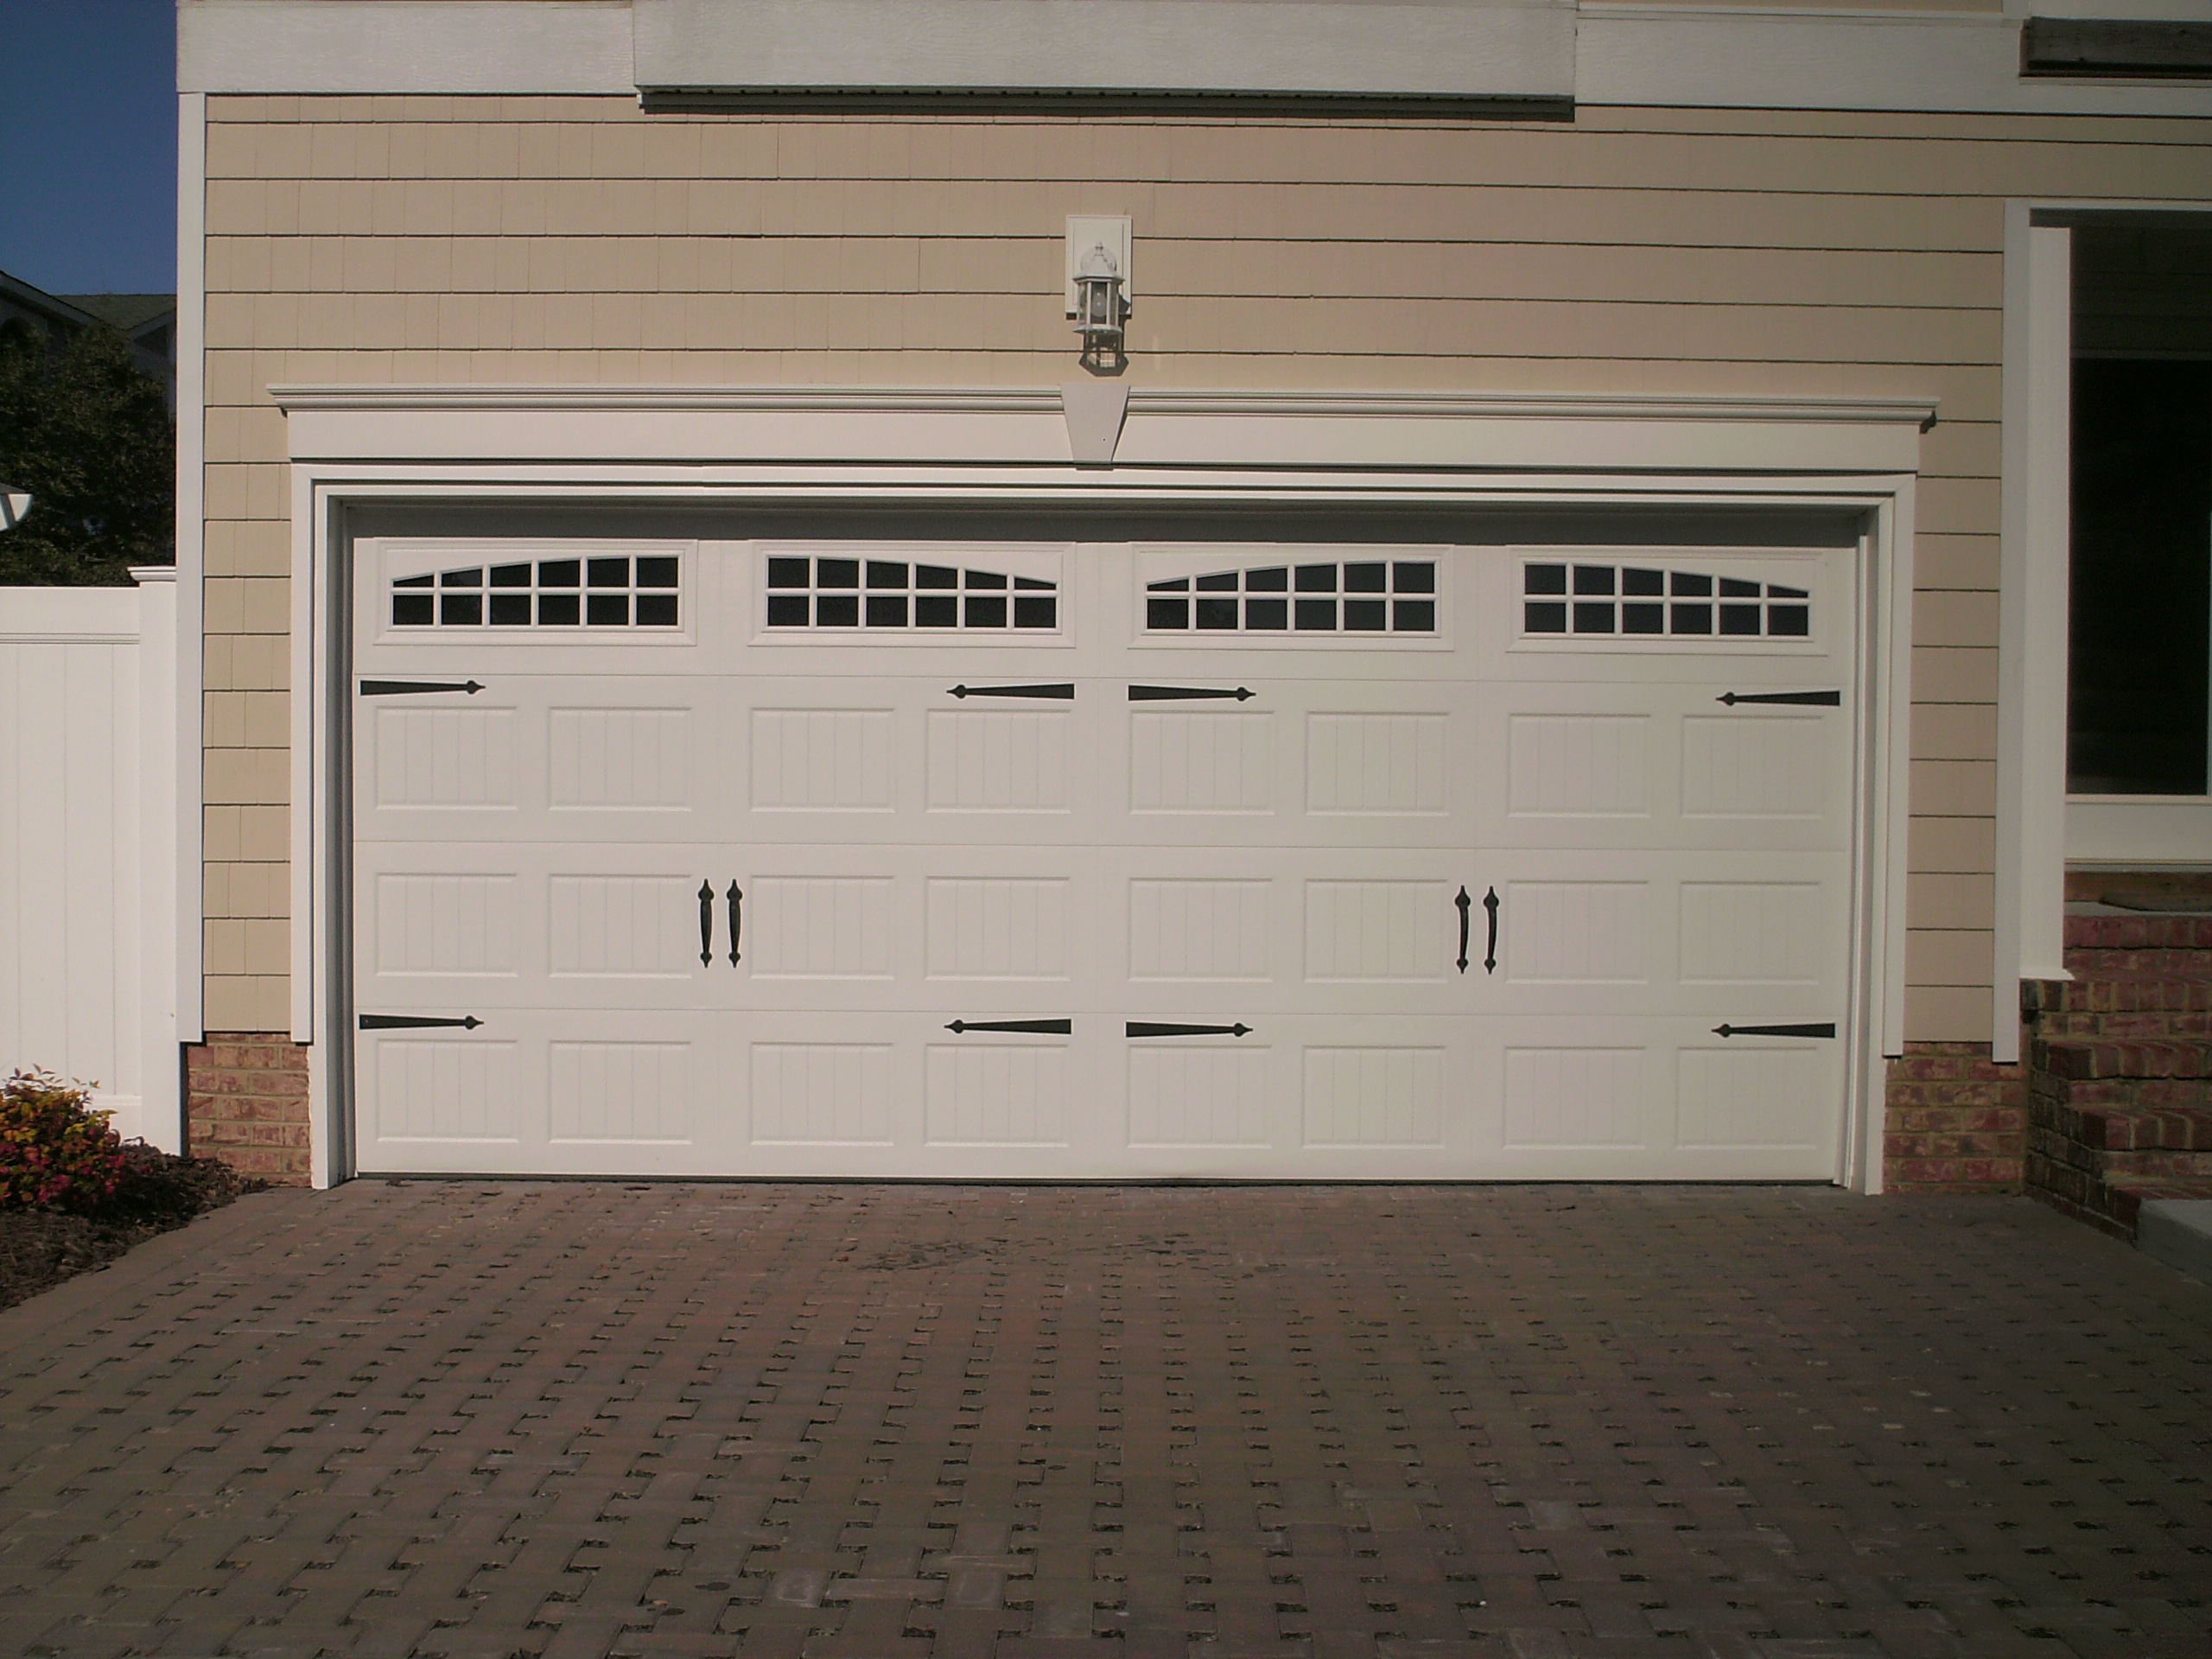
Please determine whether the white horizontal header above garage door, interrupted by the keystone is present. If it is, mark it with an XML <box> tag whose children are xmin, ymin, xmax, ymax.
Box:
<box><xmin>270</xmin><ymin>387</ymin><xmax>1933</xmax><ymax>475</ymax></box>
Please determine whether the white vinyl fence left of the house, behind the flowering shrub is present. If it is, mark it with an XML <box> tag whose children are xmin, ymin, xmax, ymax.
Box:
<box><xmin>0</xmin><ymin>569</ymin><xmax>183</xmax><ymax>1153</ymax></box>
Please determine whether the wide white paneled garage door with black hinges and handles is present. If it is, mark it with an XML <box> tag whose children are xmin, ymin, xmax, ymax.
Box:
<box><xmin>352</xmin><ymin>540</ymin><xmax>1856</xmax><ymax>1179</ymax></box>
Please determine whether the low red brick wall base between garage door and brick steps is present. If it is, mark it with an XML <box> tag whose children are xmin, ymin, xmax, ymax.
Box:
<box><xmin>1883</xmin><ymin>1042</ymin><xmax>2029</xmax><ymax>1192</ymax></box>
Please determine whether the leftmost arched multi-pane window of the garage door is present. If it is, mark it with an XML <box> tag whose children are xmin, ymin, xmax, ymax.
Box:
<box><xmin>391</xmin><ymin>556</ymin><xmax>681</xmax><ymax>631</ymax></box>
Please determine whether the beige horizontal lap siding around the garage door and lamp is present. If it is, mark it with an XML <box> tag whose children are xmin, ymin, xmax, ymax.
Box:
<box><xmin>206</xmin><ymin>98</ymin><xmax>2212</xmax><ymax>1039</ymax></box>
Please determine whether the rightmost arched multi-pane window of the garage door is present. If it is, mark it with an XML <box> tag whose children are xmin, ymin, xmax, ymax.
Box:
<box><xmin>1522</xmin><ymin>560</ymin><xmax>1812</xmax><ymax>639</ymax></box>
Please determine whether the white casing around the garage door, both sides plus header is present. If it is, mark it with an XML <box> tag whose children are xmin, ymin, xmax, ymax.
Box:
<box><xmin>289</xmin><ymin>385</ymin><xmax>1933</xmax><ymax>1192</ymax></box>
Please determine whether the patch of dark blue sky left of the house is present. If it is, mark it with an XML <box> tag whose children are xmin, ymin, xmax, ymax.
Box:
<box><xmin>0</xmin><ymin>0</ymin><xmax>177</xmax><ymax>294</ymax></box>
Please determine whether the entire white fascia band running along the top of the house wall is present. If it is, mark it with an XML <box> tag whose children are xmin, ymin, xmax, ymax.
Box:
<box><xmin>177</xmin><ymin>0</ymin><xmax>2212</xmax><ymax>115</ymax></box>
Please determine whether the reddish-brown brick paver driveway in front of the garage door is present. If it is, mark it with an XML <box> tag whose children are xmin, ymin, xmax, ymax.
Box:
<box><xmin>0</xmin><ymin>1181</ymin><xmax>2212</xmax><ymax>1659</ymax></box>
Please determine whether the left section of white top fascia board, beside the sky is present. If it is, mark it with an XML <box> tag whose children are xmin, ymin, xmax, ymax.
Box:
<box><xmin>177</xmin><ymin>0</ymin><xmax>635</xmax><ymax>93</ymax></box>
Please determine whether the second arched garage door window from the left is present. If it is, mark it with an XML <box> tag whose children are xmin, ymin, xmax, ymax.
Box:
<box><xmin>767</xmin><ymin>553</ymin><xmax>1059</xmax><ymax>632</ymax></box>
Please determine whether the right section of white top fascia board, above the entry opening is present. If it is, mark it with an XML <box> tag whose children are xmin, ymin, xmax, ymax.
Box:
<box><xmin>1575</xmin><ymin>4</ymin><xmax>2212</xmax><ymax>115</ymax></box>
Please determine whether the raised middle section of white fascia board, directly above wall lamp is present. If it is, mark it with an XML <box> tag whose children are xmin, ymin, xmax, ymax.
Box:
<box><xmin>635</xmin><ymin>0</ymin><xmax>1575</xmax><ymax>98</ymax></box>
